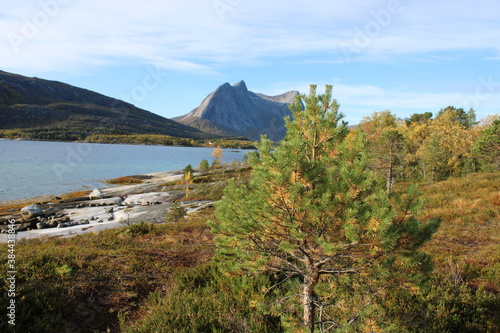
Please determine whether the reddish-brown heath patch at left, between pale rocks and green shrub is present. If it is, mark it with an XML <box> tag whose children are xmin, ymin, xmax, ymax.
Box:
<box><xmin>0</xmin><ymin>212</ymin><xmax>213</xmax><ymax>332</ymax></box>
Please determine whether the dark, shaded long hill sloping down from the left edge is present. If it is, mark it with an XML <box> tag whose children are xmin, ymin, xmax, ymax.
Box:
<box><xmin>0</xmin><ymin>71</ymin><xmax>209</xmax><ymax>139</ymax></box>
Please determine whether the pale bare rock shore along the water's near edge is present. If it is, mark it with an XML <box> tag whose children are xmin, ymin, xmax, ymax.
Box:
<box><xmin>0</xmin><ymin>170</ymin><xmax>212</xmax><ymax>242</ymax></box>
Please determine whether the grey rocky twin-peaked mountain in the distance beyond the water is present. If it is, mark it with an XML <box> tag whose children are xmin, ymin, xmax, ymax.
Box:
<box><xmin>172</xmin><ymin>81</ymin><xmax>299</xmax><ymax>141</ymax></box>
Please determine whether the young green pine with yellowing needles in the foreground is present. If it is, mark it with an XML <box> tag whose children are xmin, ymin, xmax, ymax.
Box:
<box><xmin>212</xmin><ymin>85</ymin><xmax>438</xmax><ymax>332</ymax></box>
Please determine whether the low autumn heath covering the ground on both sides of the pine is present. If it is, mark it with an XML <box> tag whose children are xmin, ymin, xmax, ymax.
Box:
<box><xmin>0</xmin><ymin>170</ymin><xmax>500</xmax><ymax>333</ymax></box>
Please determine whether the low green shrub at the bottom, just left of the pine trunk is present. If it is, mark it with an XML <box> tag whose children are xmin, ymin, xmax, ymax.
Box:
<box><xmin>125</xmin><ymin>263</ymin><xmax>283</xmax><ymax>333</ymax></box>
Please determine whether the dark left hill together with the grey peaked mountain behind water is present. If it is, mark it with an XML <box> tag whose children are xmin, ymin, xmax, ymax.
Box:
<box><xmin>0</xmin><ymin>71</ymin><xmax>298</xmax><ymax>141</ymax></box>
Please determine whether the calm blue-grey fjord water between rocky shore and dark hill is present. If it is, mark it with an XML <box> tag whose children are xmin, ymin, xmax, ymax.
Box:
<box><xmin>0</xmin><ymin>140</ymin><xmax>246</xmax><ymax>202</ymax></box>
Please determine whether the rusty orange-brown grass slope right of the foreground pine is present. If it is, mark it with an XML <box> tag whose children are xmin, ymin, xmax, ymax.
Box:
<box><xmin>420</xmin><ymin>172</ymin><xmax>500</xmax><ymax>290</ymax></box>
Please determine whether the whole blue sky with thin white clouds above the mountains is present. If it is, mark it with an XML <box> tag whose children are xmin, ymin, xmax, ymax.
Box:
<box><xmin>0</xmin><ymin>0</ymin><xmax>500</xmax><ymax>124</ymax></box>
